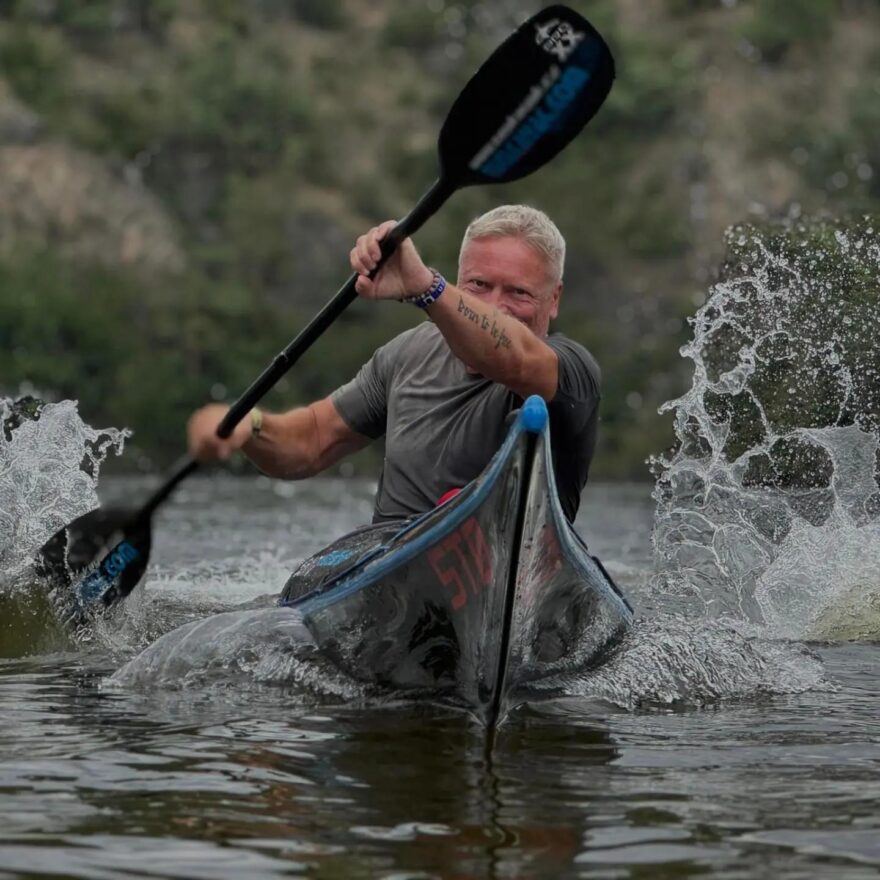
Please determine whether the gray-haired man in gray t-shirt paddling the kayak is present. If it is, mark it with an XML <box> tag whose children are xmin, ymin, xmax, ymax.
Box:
<box><xmin>188</xmin><ymin>205</ymin><xmax>599</xmax><ymax>522</ymax></box>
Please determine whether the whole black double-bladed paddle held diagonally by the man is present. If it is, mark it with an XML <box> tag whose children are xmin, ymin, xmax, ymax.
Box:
<box><xmin>41</xmin><ymin>6</ymin><xmax>614</xmax><ymax>621</ymax></box>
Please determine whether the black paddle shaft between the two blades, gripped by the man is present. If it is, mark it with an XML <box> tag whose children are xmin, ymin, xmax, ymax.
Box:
<box><xmin>134</xmin><ymin>177</ymin><xmax>458</xmax><ymax>522</ymax></box>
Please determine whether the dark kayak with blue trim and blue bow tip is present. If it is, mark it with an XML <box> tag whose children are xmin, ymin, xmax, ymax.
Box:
<box><xmin>279</xmin><ymin>396</ymin><xmax>633</xmax><ymax>726</ymax></box>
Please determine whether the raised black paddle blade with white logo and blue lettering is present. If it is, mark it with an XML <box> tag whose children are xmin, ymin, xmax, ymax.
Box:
<box><xmin>439</xmin><ymin>6</ymin><xmax>614</xmax><ymax>186</ymax></box>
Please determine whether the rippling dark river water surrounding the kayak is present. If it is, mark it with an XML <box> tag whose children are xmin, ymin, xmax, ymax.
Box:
<box><xmin>0</xmin><ymin>475</ymin><xmax>880</xmax><ymax>880</ymax></box>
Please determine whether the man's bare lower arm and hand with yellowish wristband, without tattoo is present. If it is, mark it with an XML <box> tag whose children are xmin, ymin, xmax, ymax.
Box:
<box><xmin>187</xmin><ymin>397</ymin><xmax>370</xmax><ymax>480</ymax></box>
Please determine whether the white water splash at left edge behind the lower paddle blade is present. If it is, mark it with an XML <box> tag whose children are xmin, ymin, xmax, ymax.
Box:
<box><xmin>0</xmin><ymin>400</ymin><xmax>128</xmax><ymax>594</ymax></box>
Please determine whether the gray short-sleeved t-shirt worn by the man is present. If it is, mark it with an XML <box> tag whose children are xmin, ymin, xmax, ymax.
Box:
<box><xmin>331</xmin><ymin>321</ymin><xmax>600</xmax><ymax>522</ymax></box>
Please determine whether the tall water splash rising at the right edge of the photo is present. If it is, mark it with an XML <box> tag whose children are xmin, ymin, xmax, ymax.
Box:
<box><xmin>654</xmin><ymin>221</ymin><xmax>880</xmax><ymax>638</ymax></box>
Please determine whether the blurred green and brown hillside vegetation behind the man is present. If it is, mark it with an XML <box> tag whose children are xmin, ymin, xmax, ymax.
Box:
<box><xmin>0</xmin><ymin>0</ymin><xmax>880</xmax><ymax>479</ymax></box>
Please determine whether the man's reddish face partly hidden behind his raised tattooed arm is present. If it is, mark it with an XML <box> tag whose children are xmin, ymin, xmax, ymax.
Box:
<box><xmin>458</xmin><ymin>236</ymin><xmax>562</xmax><ymax>336</ymax></box>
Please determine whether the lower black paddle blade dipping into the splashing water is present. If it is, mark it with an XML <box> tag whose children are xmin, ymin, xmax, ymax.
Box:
<box><xmin>39</xmin><ymin>508</ymin><xmax>152</xmax><ymax>625</ymax></box>
